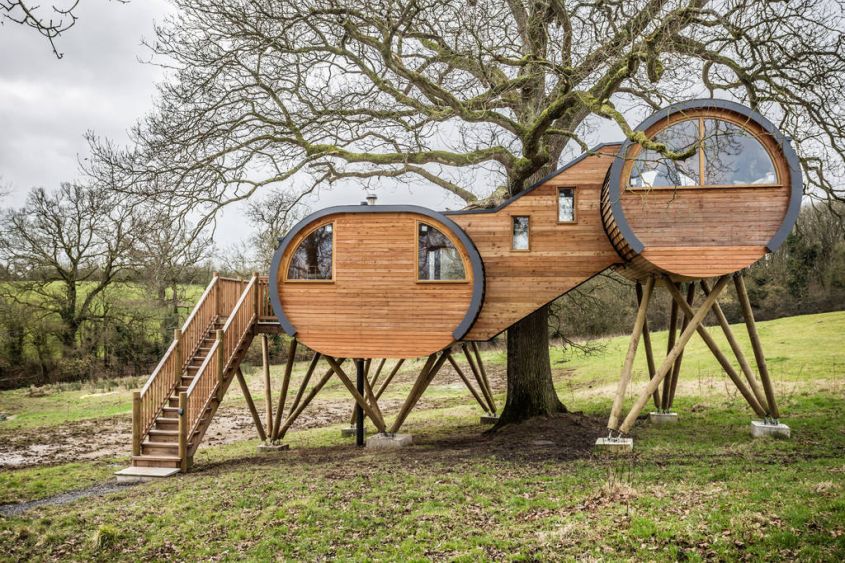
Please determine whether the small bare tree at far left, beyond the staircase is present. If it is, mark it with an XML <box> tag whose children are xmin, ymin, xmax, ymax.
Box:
<box><xmin>0</xmin><ymin>184</ymin><xmax>146</xmax><ymax>354</ymax></box>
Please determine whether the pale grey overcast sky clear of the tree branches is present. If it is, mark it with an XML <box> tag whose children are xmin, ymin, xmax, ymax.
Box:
<box><xmin>0</xmin><ymin>0</ymin><xmax>615</xmax><ymax>247</ymax></box>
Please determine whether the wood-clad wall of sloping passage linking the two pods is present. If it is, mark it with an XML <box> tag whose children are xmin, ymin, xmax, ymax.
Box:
<box><xmin>449</xmin><ymin>145</ymin><xmax>621</xmax><ymax>340</ymax></box>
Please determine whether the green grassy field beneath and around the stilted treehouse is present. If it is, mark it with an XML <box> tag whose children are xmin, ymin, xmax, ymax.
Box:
<box><xmin>0</xmin><ymin>313</ymin><xmax>845</xmax><ymax>561</ymax></box>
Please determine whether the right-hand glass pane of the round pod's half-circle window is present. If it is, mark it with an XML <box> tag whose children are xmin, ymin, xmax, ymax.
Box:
<box><xmin>704</xmin><ymin>119</ymin><xmax>777</xmax><ymax>186</ymax></box>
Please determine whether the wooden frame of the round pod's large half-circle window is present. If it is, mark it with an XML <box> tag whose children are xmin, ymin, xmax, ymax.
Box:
<box><xmin>623</xmin><ymin>112</ymin><xmax>784</xmax><ymax>192</ymax></box>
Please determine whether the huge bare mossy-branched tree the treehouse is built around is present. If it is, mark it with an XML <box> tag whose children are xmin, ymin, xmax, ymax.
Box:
<box><xmin>90</xmin><ymin>0</ymin><xmax>845</xmax><ymax>422</ymax></box>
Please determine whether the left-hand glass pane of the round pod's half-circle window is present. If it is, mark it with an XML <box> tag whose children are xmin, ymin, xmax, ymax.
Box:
<box><xmin>630</xmin><ymin>119</ymin><xmax>699</xmax><ymax>188</ymax></box>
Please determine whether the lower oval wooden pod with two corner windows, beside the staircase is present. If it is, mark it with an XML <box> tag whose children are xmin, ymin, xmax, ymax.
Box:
<box><xmin>270</xmin><ymin>205</ymin><xmax>484</xmax><ymax>358</ymax></box>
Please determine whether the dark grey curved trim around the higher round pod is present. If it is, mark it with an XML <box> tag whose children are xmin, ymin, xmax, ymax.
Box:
<box><xmin>608</xmin><ymin>99</ymin><xmax>804</xmax><ymax>254</ymax></box>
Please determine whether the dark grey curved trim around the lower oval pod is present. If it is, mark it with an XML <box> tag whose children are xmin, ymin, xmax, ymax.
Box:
<box><xmin>269</xmin><ymin>205</ymin><xmax>484</xmax><ymax>340</ymax></box>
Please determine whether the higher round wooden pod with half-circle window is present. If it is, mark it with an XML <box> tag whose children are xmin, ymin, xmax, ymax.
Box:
<box><xmin>602</xmin><ymin>100</ymin><xmax>803</xmax><ymax>280</ymax></box>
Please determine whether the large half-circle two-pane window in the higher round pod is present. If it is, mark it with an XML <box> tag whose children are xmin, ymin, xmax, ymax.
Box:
<box><xmin>628</xmin><ymin>118</ymin><xmax>777</xmax><ymax>188</ymax></box>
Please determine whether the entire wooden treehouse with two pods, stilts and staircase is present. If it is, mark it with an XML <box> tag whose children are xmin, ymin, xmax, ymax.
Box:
<box><xmin>118</xmin><ymin>100</ymin><xmax>802</xmax><ymax>478</ymax></box>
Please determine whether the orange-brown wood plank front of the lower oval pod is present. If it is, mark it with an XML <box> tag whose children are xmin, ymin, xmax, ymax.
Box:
<box><xmin>279</xmin><ymin>213</ymin><xmax>473</xmax><ymax>358</ymax></box>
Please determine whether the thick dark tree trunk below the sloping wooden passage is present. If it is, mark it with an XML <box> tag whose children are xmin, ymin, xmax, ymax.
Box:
<box><xmin>493</xmin><ymin>305</ymin><xmax>566</xmax><ymax>430</ymax></box>
